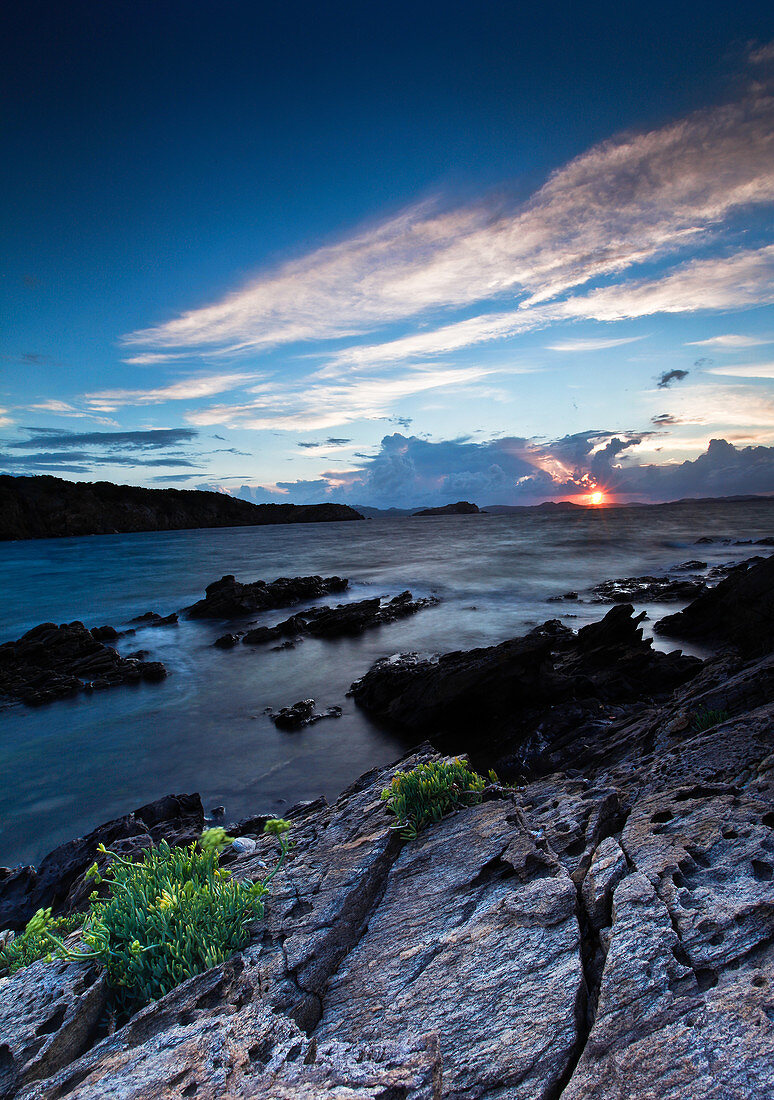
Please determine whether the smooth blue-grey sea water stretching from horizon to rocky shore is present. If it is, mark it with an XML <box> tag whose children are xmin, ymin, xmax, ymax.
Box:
<box><xmin>0</xmin><ymin>502</ymin><xmax>774</xmax><ymax>865</ymax></box>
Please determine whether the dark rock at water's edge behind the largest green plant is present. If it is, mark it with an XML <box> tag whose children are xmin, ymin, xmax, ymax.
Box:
<box><xmin>0</xmin><ymin>794</ymin><xmax>204</xmax><ymax>930</ymax></box>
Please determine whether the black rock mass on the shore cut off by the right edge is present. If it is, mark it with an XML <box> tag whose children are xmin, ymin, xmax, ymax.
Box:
<box><xmin>655</xmin><ymin>556</ymin><xmax>774</xmax><ymax>653</ymax></box>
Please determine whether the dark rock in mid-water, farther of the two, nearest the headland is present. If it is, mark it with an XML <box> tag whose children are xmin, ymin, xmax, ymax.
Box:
<box><xmin>186</xmin><ymin>573</ymin><xmax>350</xmax><ymax>619</ymax></box>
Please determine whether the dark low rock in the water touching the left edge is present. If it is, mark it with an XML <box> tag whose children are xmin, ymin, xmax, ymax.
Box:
<box><xmin>0</xmin><ymin>623</ymin><xmax>166</xmax><ymax>704</ymax></box>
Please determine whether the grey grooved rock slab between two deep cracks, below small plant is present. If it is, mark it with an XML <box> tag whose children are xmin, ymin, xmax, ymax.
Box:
<box><xmin>316</xmin><ymin>802</ymin><xmax>585</xmax><ymax>1100</ymax></box>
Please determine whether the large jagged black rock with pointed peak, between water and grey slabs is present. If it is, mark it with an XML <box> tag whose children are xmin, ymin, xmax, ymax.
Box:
<box><xmin>352</xmin><ymin>604</ymin><xmax>700</xmax><ymax>777</ymax></box>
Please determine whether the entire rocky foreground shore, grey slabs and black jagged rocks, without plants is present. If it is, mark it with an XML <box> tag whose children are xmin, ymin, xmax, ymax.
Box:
<box><xmin>0</xmin><ymin>558</ymin><xmax>774</xmax><ymax>1100</ymax></box>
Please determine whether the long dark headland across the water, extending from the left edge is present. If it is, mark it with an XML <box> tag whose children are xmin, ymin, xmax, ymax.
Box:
<box><xmin>0</xmin><ymin>474</ymin><xmax>363</xmax><ymax>540</ymax></box>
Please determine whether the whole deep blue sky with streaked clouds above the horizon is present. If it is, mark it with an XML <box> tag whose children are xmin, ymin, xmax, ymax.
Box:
<box><xmin>0</xmin><ymin>0</ymin><xmax>774</xmax><ymax>508</ymax></box>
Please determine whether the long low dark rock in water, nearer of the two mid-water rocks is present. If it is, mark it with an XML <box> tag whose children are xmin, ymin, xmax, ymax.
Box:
<box><xmin>242</xmin><ymin>592</ymin><xmax>438</xmax><ymax>648</ymax></box>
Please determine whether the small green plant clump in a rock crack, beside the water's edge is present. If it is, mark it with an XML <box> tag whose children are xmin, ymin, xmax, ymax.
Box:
<box><xmin>382</xmin><ymin>760</ymin><xmax>486</xmax><ymax>840</ymax></box>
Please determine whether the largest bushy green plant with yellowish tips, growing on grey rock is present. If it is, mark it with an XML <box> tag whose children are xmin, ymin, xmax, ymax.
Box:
<box><xmin>36</xmin><ymin>818</ymin><xmax>290</xmax><ymax>1018</ymax></box>
